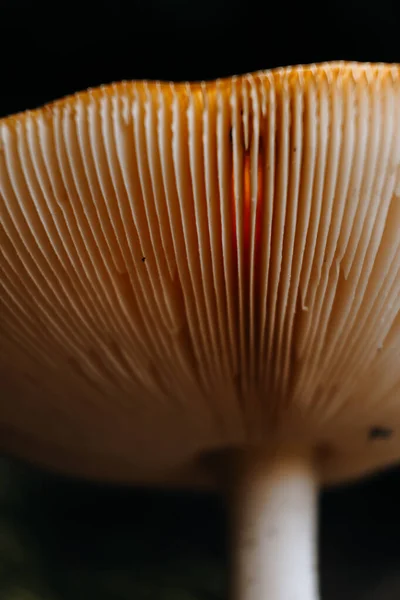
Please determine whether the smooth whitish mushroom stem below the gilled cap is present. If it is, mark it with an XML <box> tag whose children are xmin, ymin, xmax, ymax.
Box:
<box><xmin>232</xmin><ymin>454</ymin><xmax>319</xmax><ymax>600</ymax></box>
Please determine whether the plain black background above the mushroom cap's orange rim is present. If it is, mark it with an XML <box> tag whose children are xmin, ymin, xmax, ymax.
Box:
<box><xmin>0</xmin><ymin>0</ymin><xmax>400</xmax><ymax>116</ymax></box>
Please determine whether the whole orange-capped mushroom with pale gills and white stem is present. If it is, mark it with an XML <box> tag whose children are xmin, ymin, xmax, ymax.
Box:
<box><xmin>0</xmin><ymin>63</ymin><xmax>400</xmax><ymax>600</ymax></box>
